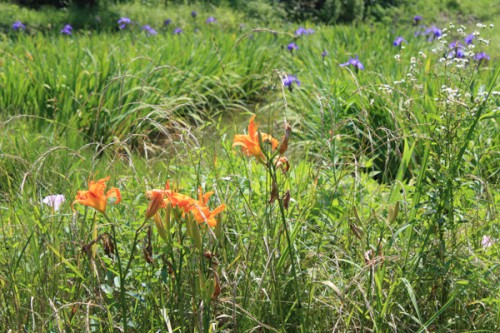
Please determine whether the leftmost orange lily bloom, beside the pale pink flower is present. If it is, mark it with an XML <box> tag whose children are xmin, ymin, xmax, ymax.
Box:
<box><xmin>71</xmin><ymin>176</ymin><xmax>121</xmax><ymax>213</ymax></box>
